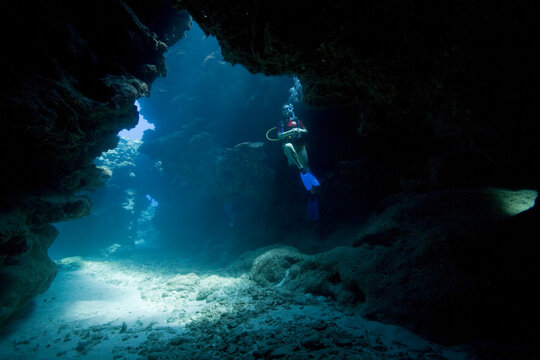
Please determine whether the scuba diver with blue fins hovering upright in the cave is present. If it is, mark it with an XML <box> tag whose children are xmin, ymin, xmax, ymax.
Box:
<box><xmin>266</xmin><ymin>104</ymin><xmax>321</xmax><ymax>221</ymax></box>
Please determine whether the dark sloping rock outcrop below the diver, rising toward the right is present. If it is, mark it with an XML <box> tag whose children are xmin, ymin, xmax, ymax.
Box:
<box><xmin>249</xmin><ymin>189</ymin><xmax>540</xmax><ymax>345</ymax></box>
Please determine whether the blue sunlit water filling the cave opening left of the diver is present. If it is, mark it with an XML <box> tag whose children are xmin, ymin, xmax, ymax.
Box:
<box><xmin>49</xmin><ymin>22</ymin><xmax>309</xmax><ymax>261</ymax></box>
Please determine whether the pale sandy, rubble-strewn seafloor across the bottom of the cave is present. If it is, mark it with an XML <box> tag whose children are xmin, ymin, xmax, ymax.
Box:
<box><xmin>0</xmin><ymin>254</ymin><xmax>469</xmax><ymax>359</ymax></box>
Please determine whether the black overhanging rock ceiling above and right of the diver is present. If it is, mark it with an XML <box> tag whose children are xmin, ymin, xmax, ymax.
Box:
<box><xmin>177</xmin><ymin>0</ymin><xmax>540</xmax><ymax>194</ymax></box>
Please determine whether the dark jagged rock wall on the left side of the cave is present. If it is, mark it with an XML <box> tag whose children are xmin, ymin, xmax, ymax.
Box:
<box><xmin>0</xmin><ymin>0</ymin><xmax>191</xmax><ymax>323</ymax></box>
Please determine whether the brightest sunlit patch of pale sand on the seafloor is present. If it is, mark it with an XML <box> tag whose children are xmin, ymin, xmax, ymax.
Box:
<box><xmin>57</xmin><ymin>258</ymin><xmax>236</xmax><ymax>326</ymax></box>
